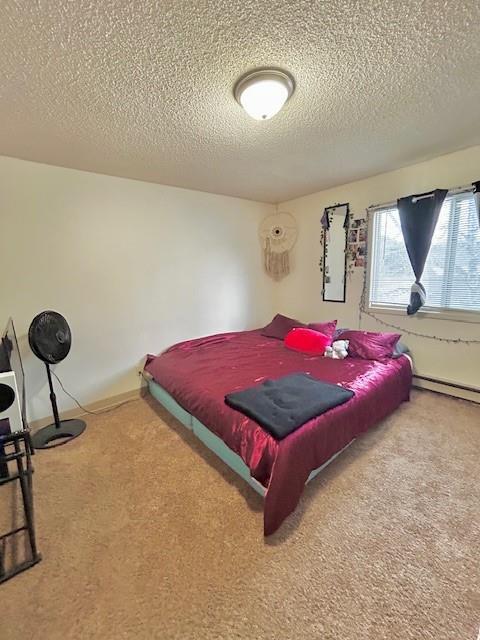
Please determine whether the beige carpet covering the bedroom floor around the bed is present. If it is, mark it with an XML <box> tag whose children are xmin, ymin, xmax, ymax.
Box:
<box><xmin>0</xmin><ymin>392</ymin><xmax>480</xmax><ymax>640</ymax></box>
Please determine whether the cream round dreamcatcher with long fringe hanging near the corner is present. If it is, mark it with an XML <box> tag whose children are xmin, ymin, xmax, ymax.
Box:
<box><xmin>259</xmin><ymin>212</ymin><xmax>297</xmax><ymax>280</ymax></box>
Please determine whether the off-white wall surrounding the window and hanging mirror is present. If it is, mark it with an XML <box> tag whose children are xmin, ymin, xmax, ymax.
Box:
<box><xmin>274</xmin><ymin>146</ymin><xmax>480</xmax><ymax>396</ymax></box>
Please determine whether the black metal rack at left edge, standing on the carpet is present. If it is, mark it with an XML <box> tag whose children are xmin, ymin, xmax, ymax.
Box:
<box><xmin>0</xmin><ymin>429</ymin><xmax>42</xmax><ymax>584</ymax></box>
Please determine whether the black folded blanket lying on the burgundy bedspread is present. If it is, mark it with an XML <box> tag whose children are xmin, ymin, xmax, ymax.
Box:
<box><xmin>225</xmin><ymin>373</ymin><xmax>355</xmax><ymax>440</ymax></box>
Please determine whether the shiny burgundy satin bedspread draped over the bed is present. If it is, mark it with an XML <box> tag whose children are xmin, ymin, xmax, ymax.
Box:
<box><xmin>145</xmin><ymin>330</ymin><xmax>412</xmax><ymax>535</ymax></box>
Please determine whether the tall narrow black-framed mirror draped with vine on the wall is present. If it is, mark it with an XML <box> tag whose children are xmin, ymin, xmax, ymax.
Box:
<box><xmin>322</xmin><ymin>203</ymin><xmax>350</xmax><ymax>302</ymax></box>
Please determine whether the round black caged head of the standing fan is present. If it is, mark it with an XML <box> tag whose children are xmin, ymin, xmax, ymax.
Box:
<box><xmin>28</xmin><ymin>311</ymin><xmax>72</xmax><ymax>364</ymax></box>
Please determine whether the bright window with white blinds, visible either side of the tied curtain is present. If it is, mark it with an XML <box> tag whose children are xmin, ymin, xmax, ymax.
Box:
<box><xmin>369</xmin><ymin>191</ymin><xmax>480</xmax><ymax>312</ymax></box>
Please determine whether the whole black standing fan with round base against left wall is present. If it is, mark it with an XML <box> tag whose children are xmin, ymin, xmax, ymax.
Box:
<box><xmin>28</xmin><ymin>311</ymin><xmax>87</xmax><ymax>449</ymax></box>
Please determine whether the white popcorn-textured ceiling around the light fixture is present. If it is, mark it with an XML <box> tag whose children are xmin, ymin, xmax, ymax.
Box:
<box><xmin>0</xmin><ymin>0</ymin><xmax>480</xmax><ymax>202</ymax></box>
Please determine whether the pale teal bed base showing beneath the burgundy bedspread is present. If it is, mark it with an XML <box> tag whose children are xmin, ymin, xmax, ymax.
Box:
<box><xmin>148</xmin><ymin>379</ymin><xmax>353</xmax><ymax>497</ymax></box>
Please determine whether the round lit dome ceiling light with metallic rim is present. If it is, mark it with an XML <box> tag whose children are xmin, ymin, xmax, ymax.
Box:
<box><xmin>234</xmin><ymin>69</ymin><xmax>295</xmax><ymax>120</ymax></box>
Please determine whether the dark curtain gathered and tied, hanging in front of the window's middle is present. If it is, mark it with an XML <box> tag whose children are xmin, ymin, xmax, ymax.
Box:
<box><xmin>397</xmin><ymin>189</ymin><xmax>448</xmax><ymax>316</ymax></box>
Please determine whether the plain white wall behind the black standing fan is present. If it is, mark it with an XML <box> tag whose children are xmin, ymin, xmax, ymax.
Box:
<box><xmin>0</xmin><ymin>157</ymin><xmax>272</xmax><ymax>419</ymax></box>
